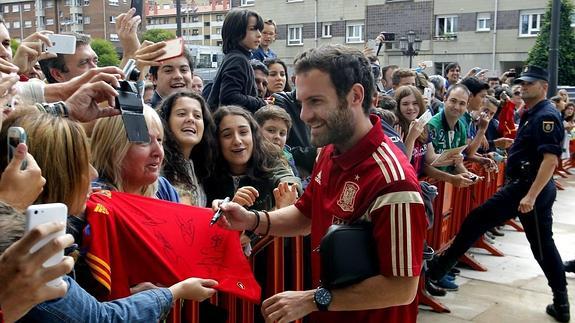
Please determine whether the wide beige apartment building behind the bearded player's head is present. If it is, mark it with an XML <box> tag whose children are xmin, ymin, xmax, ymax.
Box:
<box><xmin>232</xmin><ymin>0</ymin><xmax>575</xmax><ymax>73</ymax></box>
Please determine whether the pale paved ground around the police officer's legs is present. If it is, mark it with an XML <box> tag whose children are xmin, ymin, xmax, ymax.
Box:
<box><xmin>418</xmin><ymin>176</ymin><xmax>575</xmax><ymax>323</ymax></box>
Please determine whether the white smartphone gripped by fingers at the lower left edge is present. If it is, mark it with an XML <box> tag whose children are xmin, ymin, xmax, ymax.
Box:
<box><xmin>26</xmin><ymin>203</ymin><xmax>68</xmax><ymax>286</ymax></box>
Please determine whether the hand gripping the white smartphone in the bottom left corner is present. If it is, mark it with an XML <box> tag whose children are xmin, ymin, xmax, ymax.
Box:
<box><xmin>0</xmin><ymin>222</ymin><xmax>74</xmax><ymax>322</ymax></box>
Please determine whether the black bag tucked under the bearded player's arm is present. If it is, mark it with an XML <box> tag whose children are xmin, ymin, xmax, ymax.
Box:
<box><xmin>319</xmin><ymin>222</ymin><xmax>379</xmax><ymax>289</ymax></box>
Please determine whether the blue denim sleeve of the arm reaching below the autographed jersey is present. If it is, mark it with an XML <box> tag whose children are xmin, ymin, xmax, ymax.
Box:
<box><xmin>19</xmin><ymin>276</ymin><xmax>173</xmax><ymax>323</ymax></box>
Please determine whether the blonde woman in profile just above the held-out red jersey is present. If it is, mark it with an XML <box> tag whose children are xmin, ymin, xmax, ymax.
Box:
<box><xmin>91</xmin><ymin>106</ymin><xmax>179</xmax><ymax>202</ymax></box>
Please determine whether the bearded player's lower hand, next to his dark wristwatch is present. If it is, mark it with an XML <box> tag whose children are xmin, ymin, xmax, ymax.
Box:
<box><xmin>262</xmin><ymin>290</ymin><xmax>317</xmax><ymax>323</ymax></box>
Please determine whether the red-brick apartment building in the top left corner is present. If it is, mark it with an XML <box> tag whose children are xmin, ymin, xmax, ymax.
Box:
<box><xmin>0</xmin><ymin>0</ymin><xmax>130</xmax><ymax>46</ymax></box>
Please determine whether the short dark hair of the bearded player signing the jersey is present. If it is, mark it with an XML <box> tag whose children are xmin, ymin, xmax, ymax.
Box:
<box><xmin>294</xmin><ymin>45</ymin><xmax>375</xmax><ymax>114</ymax></box>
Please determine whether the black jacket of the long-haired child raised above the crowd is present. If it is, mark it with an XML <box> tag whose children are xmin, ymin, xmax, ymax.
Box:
<box><xmin>208</xmin><ymin>49</ymin><xmax>266</xmax><ymax>113</ymax></box>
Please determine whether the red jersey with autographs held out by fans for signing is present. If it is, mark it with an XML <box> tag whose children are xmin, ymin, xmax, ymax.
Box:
<box><xmin>83</xmin><ymin>191</ymin><xmax>261</xmax><ymax>303</ymax></box>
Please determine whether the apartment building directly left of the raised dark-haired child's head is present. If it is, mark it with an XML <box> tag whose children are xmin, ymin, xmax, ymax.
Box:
<box><xmin>146</xmin><ymin>0</ymin><xmax>230</xmax><ymax>68</ymax></box>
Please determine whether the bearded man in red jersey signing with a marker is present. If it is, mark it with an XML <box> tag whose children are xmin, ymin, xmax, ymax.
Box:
<box><xmin>216</xmin><ymin>45</ymin><xmax>427</xmax><ymax>323</ymax></box>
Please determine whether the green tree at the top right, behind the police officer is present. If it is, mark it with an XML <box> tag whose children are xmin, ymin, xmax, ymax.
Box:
<box><xmin>527</xmin><ymin>0</ymin><xmax>575</xmax><ymax>85</ymax></box>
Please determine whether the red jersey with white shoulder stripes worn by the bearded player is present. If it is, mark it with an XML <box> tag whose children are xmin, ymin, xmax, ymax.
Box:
<box><xmin>296</xmin><ymin>117</ymin><xmax>427</xmax><ymax>323</ymax></box>
